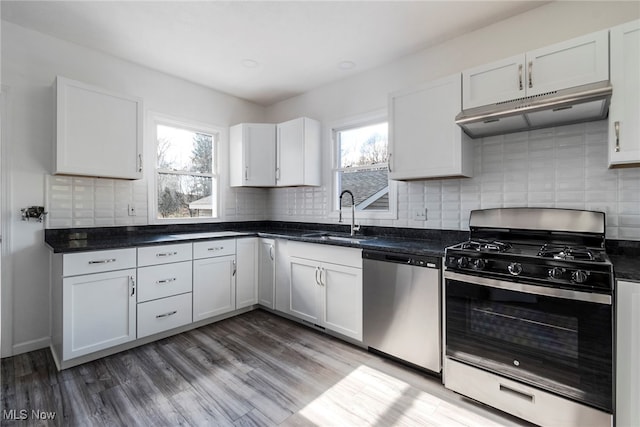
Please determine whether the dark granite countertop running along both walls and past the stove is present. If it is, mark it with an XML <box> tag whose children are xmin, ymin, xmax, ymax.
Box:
<box><xmin>45</xmin><ymin>221</ymin><xmax>640</xmax><ymax>282</ymax></box>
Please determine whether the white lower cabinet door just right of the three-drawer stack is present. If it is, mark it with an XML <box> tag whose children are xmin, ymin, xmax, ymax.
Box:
<box><xmin>193</xmin><ymin>255</ymin><xmax>236</xmax><ymax>322</ymax></box>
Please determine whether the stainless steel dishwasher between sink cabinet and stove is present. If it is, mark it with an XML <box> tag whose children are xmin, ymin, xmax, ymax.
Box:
<box><xmin>362</xmin><ymin>250</ymin><xmax>442</xmax><ymax>373</ymax></box>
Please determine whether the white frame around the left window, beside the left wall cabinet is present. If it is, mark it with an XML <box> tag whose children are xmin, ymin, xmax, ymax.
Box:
<box><xmin>145</xmin><ymin>112</ymin><xmax>227</xmax><ymax>224</ymax></box>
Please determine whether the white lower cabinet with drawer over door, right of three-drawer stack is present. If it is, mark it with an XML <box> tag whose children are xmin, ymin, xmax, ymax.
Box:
<box><xmin>193</xmin><ymin>240</ymin><xmax>236</xmax><ymax>322</ymax></box>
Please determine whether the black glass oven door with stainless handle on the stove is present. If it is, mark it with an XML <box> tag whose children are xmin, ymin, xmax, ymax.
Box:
<box><xmin>445</xmin><ymin>272</ymin><xmax>613</xmax><ymax>413</ymax></box>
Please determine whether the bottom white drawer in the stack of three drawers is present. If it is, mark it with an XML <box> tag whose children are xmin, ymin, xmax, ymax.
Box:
<box><xmin>138</xmin><ymin>292</ymin><xmax>192</xmax><ymax>338</ymax></box>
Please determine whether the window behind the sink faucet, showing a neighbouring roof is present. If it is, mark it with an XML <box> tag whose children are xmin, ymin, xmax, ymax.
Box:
<box><xmin>332</xmin><ymin>113</ymin><xmax>395</xmax><ymax>218</ymax></box>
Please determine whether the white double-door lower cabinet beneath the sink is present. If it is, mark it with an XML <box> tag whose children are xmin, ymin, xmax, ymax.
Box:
<box><xmin>289</xmin><ymin>245</ymin><xmax>362</xmax><ymax>341</ymax></box>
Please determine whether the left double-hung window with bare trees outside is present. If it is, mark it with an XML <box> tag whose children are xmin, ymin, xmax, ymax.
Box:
<box><xmin>155</xmin><ymin>120</ymin><xmax>219</xmax><ymax>222</ymax></box>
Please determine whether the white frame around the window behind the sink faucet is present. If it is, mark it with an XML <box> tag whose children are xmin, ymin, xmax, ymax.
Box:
<box><xmin>327</xmin><ymin>108</ymin><xmax>398</xmax><ymax>221</ymax></box>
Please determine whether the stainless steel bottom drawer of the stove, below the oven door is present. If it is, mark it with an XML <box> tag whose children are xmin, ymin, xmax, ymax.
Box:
<box><xmin>444</xmin><ymin>358</ymin><xmax>612</xmax><ymax>427</ymax></box>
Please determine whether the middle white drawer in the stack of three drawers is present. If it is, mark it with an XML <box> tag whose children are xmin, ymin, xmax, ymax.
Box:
<box><xmin>138</xmin><ymin>261</ymin><xmax>192</xmax><ymax>302</ymax></box>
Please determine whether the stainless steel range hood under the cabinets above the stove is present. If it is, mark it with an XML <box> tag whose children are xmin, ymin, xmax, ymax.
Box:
<box><xmin>456</xmin><ymin>81</ymin><xmax>612</xmax><ymax>138</ymax></box>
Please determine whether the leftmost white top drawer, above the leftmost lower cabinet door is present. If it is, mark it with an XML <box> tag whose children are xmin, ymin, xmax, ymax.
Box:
<box><xmin>62</xmin><ymin>248</ymin><xmax>136</xmax><ymax>277</ymax></box>
